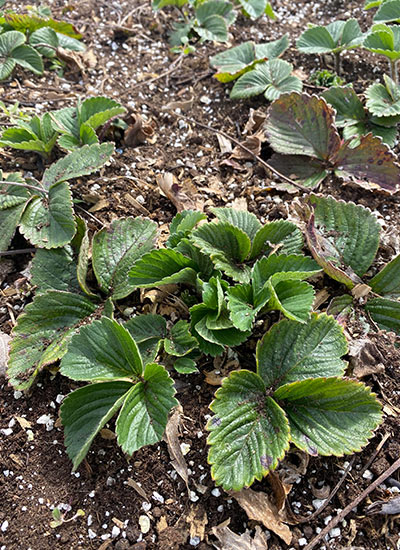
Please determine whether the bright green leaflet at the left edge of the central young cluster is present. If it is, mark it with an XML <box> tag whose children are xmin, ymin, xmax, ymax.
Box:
<box><xmin>129</xmin><ymin>248</ymin><xmax>196</xmax><ymax>288</ymax></box>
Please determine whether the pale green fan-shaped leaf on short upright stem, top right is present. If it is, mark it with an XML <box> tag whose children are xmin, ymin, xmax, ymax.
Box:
<box><xmin>296</xmin><ymin>19</ymin><xmax>363</xmax><ymax>74</ymax></box>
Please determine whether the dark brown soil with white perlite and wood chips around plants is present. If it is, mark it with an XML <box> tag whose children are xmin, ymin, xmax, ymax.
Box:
<box><xmin>0</xmin><ymin>0</ymin><xmax>400</xmax><ymax>550</ymax></box>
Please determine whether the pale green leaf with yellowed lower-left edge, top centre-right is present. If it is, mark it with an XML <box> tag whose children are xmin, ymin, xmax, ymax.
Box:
<box><xmin>210</xmin><ymin>34</ymin><xmax>289</xmax><ymax>82</ymax></box>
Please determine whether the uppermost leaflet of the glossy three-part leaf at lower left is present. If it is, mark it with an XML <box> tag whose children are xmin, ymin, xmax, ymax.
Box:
<box><xmin>61</xmin><ymin>317</ymin><xmax>143</xmax><ymax>382</ymax></box>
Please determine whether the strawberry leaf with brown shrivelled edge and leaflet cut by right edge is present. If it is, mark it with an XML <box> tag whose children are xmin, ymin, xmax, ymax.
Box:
<box><xmin>306</xmin><ymin>195</ymin><xmax>400</xmax><ymax>334</ymax></box>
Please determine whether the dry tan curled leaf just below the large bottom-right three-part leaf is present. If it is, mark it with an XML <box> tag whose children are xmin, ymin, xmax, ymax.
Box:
<box><xmin>231</xmin><ymin>489</ymin><xmax>292</xmax><ymax>544</ymax></box>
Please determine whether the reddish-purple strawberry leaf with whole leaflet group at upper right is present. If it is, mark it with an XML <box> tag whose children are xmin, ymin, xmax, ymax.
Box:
<box><xmin>265</xmin><ymin>93</ymin><xmax>400</xmax><ymax>193</ymax></box>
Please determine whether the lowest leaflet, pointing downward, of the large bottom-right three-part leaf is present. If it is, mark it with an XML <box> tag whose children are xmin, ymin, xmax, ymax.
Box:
<box><xmin>207</xmin><ymin>370</ymin><xmax>289</xmax><ymax>491</ymax></box>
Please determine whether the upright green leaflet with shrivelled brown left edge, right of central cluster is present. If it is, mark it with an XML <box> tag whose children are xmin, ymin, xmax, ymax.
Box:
<box><xmin>306</xmin><ymin>195</ymin><xmax>380</xmax><ymax>287</ymax></box>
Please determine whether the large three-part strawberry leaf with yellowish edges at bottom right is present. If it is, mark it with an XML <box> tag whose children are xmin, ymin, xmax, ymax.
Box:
<box><xmin>207</xmin><ymin>314</ymin><xmax>381</xmax><ymax>491</ymax></box>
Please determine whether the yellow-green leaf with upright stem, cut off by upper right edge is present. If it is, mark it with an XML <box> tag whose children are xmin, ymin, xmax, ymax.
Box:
<box><xmin>363</xmin><ymin>23</ymin><xmax>400</xmax><ymax>84</ymax></box>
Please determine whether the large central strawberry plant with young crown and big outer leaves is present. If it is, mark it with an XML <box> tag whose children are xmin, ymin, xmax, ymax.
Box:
<box><xmin>4</xmin><ymin>208</ymin><xmax>381</xmax><ymax>490</ymax></box>
